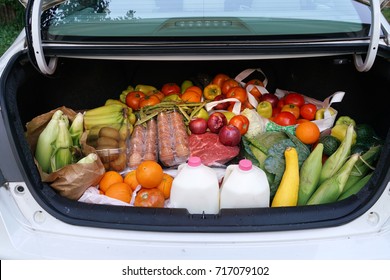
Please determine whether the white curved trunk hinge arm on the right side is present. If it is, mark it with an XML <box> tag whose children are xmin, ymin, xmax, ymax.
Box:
<box><xmin>354</xmin><ymin>0</ymin><xmax>382</xmax><ymax>72</ymax></box>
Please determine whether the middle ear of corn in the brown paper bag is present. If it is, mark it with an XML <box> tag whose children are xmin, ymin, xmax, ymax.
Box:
<box><xmin>50</xmin><ymin>118</ymin><xmax>73</xmax><ymax>172</ymax></box>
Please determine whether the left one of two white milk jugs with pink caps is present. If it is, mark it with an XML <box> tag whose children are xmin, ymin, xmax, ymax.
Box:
<box><xmin>169</xmin><ymin>157</ymin><xmax>219</xmax><ymax>214</ymax></box>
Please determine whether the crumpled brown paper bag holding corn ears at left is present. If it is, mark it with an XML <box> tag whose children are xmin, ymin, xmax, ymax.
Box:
<box><xmin>26</xmin><ymin>107</ymin><xmax>105</xmax><ymax>200</ymax></box>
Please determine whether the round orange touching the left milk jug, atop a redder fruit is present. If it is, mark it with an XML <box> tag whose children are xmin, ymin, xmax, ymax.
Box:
<box><xmin>136</xmin><ymin>160</ymin><xmax>164</xmax><ymax>189</ymax></box>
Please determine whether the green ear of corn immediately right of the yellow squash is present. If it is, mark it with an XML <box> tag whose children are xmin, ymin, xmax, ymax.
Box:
<box><xmin>298</xmin><ymin>143</ymin><xmax>324</xmax><ymax>205</ymax></box>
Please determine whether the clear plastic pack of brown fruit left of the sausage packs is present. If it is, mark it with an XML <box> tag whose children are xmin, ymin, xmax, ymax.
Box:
<box><xmin>96</xmin><ymin>124</ymin><xmax>129</xmax><ymax>172</ymax></box>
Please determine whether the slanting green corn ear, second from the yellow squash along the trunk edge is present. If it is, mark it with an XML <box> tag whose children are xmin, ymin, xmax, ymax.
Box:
<box><xmin>307</xmin><ymin>154</ymin><xmax>359</xmax><ymax>205</ymax></box>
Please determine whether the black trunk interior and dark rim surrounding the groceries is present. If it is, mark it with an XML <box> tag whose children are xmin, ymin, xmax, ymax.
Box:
<box><xmin>2</xmin><ymin>52</ymin><xmax>390</xmax><ymax>232</ymax></box>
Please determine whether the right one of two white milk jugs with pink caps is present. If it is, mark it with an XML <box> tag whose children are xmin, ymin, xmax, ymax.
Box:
<box><xmin>220</xmin><ymin>159</ymin><xmax>270</xmax><ymax>209</ymax></box>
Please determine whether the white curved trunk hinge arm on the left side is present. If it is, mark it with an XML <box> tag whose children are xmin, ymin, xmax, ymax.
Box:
<box><xmin>26</xmin><ymin>0</ymin><xmax>57</xmax><ymax>75</ymax></box>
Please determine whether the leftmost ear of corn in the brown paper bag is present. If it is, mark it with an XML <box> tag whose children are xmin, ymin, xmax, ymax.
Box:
<box><xmin>35</xmin><ymin>110</ymin><xmax>63</xmax><ymax>173</ymax></box>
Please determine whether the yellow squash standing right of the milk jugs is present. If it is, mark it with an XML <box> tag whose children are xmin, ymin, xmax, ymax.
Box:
<box><xmin>271</xmin><ymin>147</ymin><xmax>299</xmax><ymax>207</ymax></box>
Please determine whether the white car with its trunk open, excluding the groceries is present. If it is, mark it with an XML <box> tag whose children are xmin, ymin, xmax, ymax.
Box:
<box><xmin>0</xmin><ymin>0</ymin><xmax>390</xmax><ymax>260</ymax></box>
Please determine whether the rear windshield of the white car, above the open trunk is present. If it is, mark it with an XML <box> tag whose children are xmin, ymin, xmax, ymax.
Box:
<box><xmin>41</xmin><ymin>0</ymin><xmax>370</xmax><ymax>41</ymax></box>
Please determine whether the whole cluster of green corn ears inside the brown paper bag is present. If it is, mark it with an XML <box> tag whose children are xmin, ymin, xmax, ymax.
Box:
<box><xmin>35</xmin><ymin>110</ymin><xmax>84</xmax><ymax>173</ymax></box>
